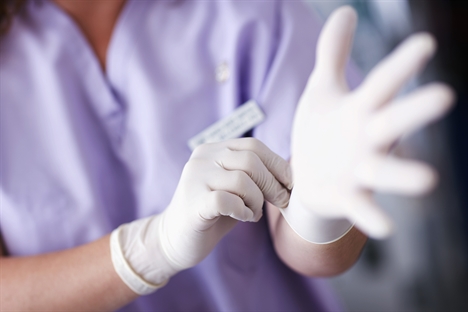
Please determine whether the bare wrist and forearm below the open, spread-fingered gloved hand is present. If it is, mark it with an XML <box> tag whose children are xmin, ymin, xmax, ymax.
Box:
<box><xmin>267</xmin><ymin>203</ymin><xmax>367</xmax><ymax>277</ymax></box>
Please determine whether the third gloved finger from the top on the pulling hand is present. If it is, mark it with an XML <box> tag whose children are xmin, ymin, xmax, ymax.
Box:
<box><xmin>207</xmin><ymin>170</ymin><xmax>264</xmax><ymax>221</ymax></box>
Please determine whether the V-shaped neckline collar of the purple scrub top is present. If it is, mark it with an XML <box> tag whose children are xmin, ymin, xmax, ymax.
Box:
<box><xmin>32</xmin><ymin>0</ymin><xmax>149</xmax><ymax>144</ymax></box>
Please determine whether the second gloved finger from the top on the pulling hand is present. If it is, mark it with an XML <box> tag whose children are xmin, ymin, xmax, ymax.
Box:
<box><xmin>217</xmin><ymin>150</ymin><xmax>289</xmax><ymax>208</ymax></box>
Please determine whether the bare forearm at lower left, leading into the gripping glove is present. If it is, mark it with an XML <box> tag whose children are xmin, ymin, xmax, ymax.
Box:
<box><xmin>0</xmin><ymin>236</ymin><xmax>137</xmax><ymax>311</ymax></box>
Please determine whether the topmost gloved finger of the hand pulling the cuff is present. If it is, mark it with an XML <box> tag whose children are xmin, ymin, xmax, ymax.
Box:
<box><xmin>223</xmin><ymin>138</ymin><xmax>292</xmax><ymax>189</ymax></box>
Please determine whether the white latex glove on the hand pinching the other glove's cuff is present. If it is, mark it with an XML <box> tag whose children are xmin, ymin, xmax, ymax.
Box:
<box><xmin>111</xmin><ymin>138</ymin><xmax>292</xmax><ymax>294</ymax></box>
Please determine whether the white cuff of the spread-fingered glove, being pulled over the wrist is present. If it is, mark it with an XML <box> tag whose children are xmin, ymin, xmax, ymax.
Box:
<box><xmin>280</xmin><ymin>191</ymin><xmax>354</xmax><ymax>244</ymax></box>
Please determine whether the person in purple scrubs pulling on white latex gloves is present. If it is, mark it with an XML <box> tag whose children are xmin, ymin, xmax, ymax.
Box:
<box><xmin>0</xmin><ymin>0</ymin><xmax>453</xmax><ymax>311</ymax></box>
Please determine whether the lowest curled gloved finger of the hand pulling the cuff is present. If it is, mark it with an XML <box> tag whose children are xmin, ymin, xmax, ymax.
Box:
<box><xmin>200</xmin><ymin>191</ymin><xmax>254</xmax><ymax>222</ymax></box>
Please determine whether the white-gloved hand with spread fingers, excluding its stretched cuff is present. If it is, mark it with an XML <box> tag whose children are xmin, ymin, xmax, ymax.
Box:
<box><xmin>285</xmin><ymin>6</ymin><xmax>453</xmax><ymax>238</ymax></box>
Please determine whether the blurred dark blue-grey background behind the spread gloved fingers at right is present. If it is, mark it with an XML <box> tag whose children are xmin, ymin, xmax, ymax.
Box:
<box><xmin>307</xmin><ymin>0</ymin><xmax>468</xmax><ymax>311</ymax></box>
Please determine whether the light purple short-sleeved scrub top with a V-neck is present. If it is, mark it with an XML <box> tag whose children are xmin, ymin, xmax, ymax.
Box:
<box><xmin>0</xmin><ymin>1</ymin><xmax>358</xmax><ymax>311</ymax></box>
